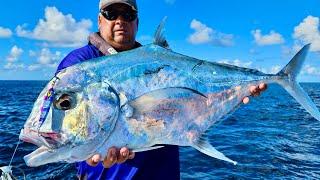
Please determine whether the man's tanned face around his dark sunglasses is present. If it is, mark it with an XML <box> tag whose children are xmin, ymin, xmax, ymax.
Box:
<box><xmin>98</xmin><ymin>4</ymin><xmax>138</xmax><ymax>51</ymax></box>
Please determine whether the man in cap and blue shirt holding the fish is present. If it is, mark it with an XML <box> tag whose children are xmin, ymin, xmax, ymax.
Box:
<box><xmin>57</xmin><ymin>0</ymin><xmax>266</xmax><ymax>179</ymax></box>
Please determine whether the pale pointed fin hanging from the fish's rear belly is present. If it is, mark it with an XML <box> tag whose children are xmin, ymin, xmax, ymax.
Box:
<box><xmin>192</xmin><ymin>139</ymin><xmax>237</xmax><ymax>165</ymax></box>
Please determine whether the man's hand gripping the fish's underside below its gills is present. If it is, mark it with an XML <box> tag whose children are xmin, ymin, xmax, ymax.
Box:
<box><xmin>87</xmin><ymin>147</ymin><xmax>134</xmax><ymax>168</ymax></box>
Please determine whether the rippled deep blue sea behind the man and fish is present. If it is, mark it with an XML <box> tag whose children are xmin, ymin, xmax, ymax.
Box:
<box><xmin>0</xmin><ymin>81</ymin><xmax>320</xmax><ymax>179</ymax></box>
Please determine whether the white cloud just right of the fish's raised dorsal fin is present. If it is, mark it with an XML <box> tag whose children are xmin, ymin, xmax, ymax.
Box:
<box><xmin>188</xmin><ymin>19</ymin><xmax>234</xmax><ymax>46</ymax></box>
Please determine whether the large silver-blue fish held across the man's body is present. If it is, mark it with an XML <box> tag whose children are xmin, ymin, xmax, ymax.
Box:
<box><xmin>20</xmin><ymin>21</ymin><xmax>320</xmax><ymax>166</ymax></box>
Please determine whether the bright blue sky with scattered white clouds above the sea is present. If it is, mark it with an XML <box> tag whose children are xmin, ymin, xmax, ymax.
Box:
<box><xmin>0</xmin><ymin>0</ymin><xmax>320</xmax><ymax>82</ymax></box>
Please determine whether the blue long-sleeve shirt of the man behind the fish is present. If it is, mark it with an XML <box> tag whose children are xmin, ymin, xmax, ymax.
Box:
<box><xmin>56</xmin><ymin>44</ymin><xmax>180</xmax><ymax>180</ymax></box>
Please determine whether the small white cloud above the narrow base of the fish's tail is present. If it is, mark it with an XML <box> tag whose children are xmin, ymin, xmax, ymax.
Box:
<box><xmin>251</xmin><ymin>29</ymin><xmax>284</xmax><ymax>46</ymax></box>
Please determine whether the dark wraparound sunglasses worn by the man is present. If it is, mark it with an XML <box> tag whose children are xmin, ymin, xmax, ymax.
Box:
<box><xmin>100</xmin><ymin>10</ymin><xmax>138</xmax><ymax>22</ymax></box>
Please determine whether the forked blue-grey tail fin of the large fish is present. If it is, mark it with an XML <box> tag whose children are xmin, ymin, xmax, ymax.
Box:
<box><xmin>276</xmin><ymin>44</ymin><xmax>320</xmax><ymax>121</ymax></box>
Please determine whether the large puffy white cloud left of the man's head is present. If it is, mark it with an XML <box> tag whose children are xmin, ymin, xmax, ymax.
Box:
<box><xmin>16</xmin><ymin>7</ymin><xmax>92</xmax><ymax>47</ymax></box>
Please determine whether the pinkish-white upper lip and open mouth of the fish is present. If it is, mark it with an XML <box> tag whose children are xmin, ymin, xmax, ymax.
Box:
<box><xmin>19</xmin><ymin>128</ymin><xmax>63</xmax><ymax>149</ymax></box>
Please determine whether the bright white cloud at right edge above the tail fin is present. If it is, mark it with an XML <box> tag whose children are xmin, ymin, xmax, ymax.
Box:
<box><xmin>293</xmin><ymin>16</ymin><xmax>320</xmax><ymax>51</ymax></box>
